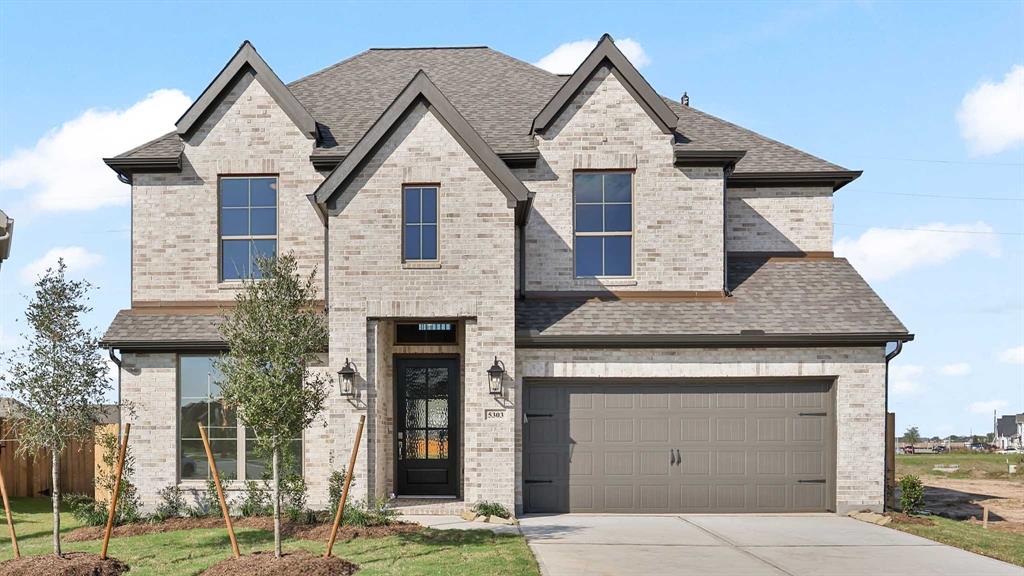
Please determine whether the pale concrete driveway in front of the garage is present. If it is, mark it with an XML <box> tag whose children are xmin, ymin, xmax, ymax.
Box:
<box><xmin>520</xmin><ymin>515</ymin><xmax>1024</xmax><ymax>576</ymax></box>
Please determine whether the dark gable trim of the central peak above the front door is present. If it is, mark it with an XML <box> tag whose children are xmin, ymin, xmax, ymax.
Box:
<box><xmin>314</xmin><ymin>70</ymin><xmax>528</xmax><ymax>216</ymax></box>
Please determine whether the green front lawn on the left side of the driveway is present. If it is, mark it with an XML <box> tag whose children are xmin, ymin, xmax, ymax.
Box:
<box><xmin>0</xmin><ymin>498</ymin><xmax>540</xmax><ymax>576</ymax></box>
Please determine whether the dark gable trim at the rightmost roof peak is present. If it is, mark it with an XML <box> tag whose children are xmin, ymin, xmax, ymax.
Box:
<box><xmin>534</xmin><ymin>34</ymin><xmax>679</xmax><ymax>134</ymax></box>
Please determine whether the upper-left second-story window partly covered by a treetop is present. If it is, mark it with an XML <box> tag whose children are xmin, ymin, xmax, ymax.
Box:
<box><xmin>219</xmin><ymin>176</ymin><xmax>278</xmax><ymax>281</ymax></box>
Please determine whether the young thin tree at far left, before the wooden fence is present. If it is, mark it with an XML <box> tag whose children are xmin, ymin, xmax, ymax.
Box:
<box><xmin>4</xmin><ymin>258</ymin><xmax>111</xmax><ymax>557</ymax></box>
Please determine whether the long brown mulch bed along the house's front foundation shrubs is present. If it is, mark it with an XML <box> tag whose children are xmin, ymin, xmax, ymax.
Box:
<box><xmin>63</xmin><ymin>517</ymin><xmax>423</xmax><ymax>542</ymax></box>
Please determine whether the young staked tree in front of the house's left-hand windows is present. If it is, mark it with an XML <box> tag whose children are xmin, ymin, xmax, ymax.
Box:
<box><xmin>218</xmin><ymin>254</ymin><xmax>331</xmax><ymax>558</ymax></box>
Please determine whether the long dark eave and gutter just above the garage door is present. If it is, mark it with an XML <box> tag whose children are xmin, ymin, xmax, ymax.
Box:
<box><xmin>515</xmin><ymin>330</ymin><xmax>913</xmax><ymax>348</ymax></box>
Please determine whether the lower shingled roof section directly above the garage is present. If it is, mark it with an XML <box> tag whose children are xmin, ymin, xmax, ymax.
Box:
<box><xmin>516</xmin><ymin>257</ymin><xmax>912</xmax><ymax>346</ymax></box>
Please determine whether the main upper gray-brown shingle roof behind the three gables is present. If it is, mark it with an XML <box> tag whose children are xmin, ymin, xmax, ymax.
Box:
<box><xmin>120</xmin><ymin>47</ymin><xmax>845</xmax><ymax>173</ymax></box>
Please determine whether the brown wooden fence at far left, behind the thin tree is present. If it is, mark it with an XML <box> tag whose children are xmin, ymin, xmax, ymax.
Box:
<box><xmin>0</xmin><ymin>418</ymin><xmax>95</xmax><ymax>496</ymax></box>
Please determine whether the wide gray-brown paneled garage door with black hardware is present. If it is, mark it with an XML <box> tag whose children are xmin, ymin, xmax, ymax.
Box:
<box><xmin>523</xmin><ymin>380</ymin><xmax>835</xmax><ymax>513</ymax></box>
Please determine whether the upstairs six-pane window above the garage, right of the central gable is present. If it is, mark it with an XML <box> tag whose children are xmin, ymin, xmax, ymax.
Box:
<box><xmin>572</xmin><ymin>172</ymin><xmax>633</xmax><ymax>277</ymax></box>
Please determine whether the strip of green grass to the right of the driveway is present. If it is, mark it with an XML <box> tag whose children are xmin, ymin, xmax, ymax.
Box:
<box><xmin>889</xmin><ymin>510</ymin><xmax>1024</xmax><ymax>566</ymax></box>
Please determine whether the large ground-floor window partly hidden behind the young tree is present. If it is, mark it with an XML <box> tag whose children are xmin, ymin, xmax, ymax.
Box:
<box><xmin>177</xmin><ymin>354</ymin><xmax>302</xmax><ymax>481</ymax></box>
